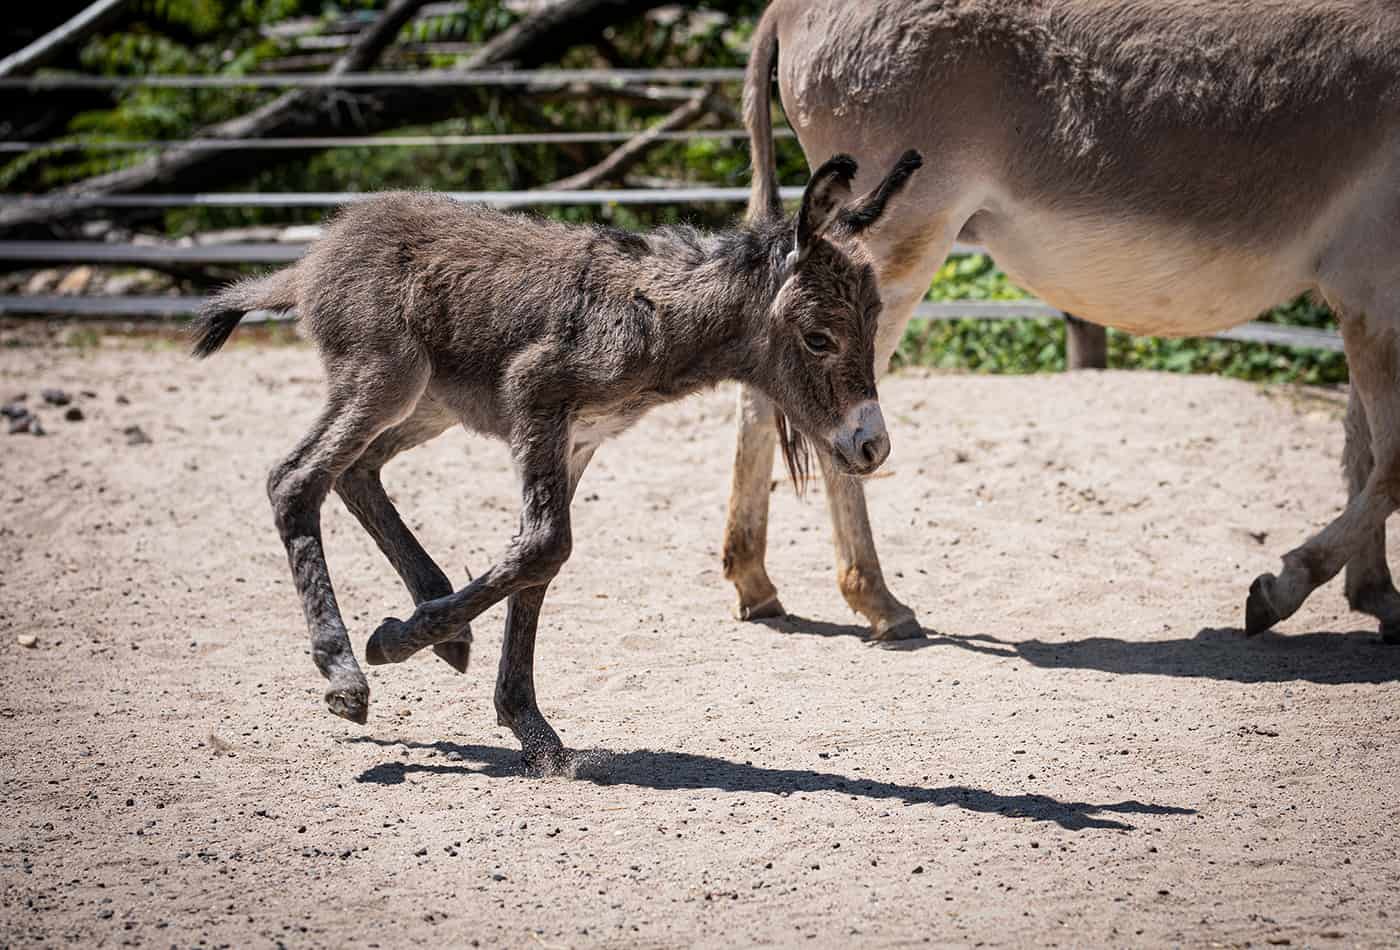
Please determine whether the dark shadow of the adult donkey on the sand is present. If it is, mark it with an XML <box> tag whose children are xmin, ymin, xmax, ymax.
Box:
<box><xmin>927</xmin><ymin>627</ymin><xmax>1400</xmax><ymax>686</ymax></box>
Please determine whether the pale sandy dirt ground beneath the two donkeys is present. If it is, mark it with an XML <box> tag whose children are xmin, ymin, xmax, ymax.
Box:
<box><xmin>0</xmin><ymin>335</ymin><xmax>1400</xmax><ymax>949</ymax></box>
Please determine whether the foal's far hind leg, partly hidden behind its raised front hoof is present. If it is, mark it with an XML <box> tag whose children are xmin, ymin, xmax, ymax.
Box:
<box><xmin>336</xmin><ymin>397</ymin><xmax>472</xmax><ymax>673</ymax></box>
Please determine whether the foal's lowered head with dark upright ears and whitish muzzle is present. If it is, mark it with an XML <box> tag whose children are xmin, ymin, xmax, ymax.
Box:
<box><xmin>763</xmin><ymin>151</ymin><xmax>923</xmax><ymax>490</ymax></box>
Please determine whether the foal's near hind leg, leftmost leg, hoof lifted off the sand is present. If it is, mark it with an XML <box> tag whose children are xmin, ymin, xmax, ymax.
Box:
<box><xmin>267</xmin><ymin>356</ymin><xmax>428</xmax><ymax>723</ymax></box>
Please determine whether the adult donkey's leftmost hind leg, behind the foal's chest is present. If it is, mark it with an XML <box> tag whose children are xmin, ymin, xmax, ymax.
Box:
<box><xmin>724</xmin><ymin>386</ymin><xmax>783</xmax><ymax>620</ymax></box>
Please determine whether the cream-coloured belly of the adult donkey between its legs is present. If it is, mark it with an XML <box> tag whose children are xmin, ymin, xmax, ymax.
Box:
<box><xmin>977</xmin><ymin>208</ymin><xmax>1316</xmax><ymax>336</ymax></box>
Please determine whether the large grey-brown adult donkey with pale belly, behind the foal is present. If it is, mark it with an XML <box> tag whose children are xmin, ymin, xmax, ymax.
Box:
<box><xmin>724</xmin><ymin>0</ymin><xmax>1400</xmax><ymax>642</ymax></box>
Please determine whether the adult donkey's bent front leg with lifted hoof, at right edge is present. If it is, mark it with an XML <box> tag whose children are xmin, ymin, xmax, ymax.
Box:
<box><xmin>1245</xmin><ymin>312</ymin><xmax>1400</xmax><ymax>634</ymax></box>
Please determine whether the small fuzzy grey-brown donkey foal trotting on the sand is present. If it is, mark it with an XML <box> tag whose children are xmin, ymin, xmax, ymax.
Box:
<box><xmin>195</xmin><ymin>153</ymin><xmax>920</xmax><ymax>765</ymax></box>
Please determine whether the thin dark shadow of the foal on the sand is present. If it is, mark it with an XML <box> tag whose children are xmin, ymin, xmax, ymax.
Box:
<box><xmin>347</xmin><ymin>736</ymin><xmax>1196</xmax><ymax>831</ymax></box>
